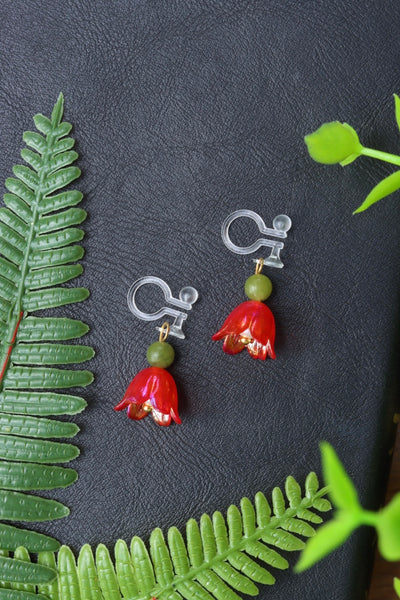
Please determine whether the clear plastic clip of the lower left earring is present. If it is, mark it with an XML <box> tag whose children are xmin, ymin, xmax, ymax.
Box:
<box><xmin>127</xmin><ymin>275</ymin><xmax>199</xmax><ymax>339</ymax></box>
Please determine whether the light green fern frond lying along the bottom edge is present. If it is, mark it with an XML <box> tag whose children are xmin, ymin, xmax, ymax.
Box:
<box><xmin>0</xmin><ymin>473</ymin><xmax>330</xmax><ymax>600</ymax></box>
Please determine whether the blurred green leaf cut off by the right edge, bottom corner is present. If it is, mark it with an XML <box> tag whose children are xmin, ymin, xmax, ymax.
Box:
<box><xmin>376</xmin><ymin>493</ymin><xmax>400</xmax><ymax>560</ymax></box>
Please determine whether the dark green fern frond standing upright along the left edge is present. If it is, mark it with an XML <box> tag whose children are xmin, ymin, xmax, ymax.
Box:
<box><xmin>0</xmin><ymin>94</ymin><xmax>94</xmax><ymax>556</ymax></box>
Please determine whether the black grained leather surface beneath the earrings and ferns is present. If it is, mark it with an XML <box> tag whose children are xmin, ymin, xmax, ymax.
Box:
<box><xmin>0</xmin><ymin>0</ymin><xmax>400</xmax><ymax>600</ymax></box>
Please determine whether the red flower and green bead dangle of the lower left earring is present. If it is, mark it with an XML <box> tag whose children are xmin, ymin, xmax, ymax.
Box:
<box><xmin>114</xmin><ymin>323</ymin><xmax>181</xmax><ymax>426</ymax></box>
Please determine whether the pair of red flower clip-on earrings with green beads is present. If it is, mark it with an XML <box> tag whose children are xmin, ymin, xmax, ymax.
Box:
<box><xmin>115</xmin><ymin>209</ymin><xmax>292</xmax><ymax>426</ymax></box>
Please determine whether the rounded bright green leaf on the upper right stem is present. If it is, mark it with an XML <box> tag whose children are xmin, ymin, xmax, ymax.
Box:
<box><xmin>304</xmin><ymin>121</ymin><xmax>363</xmax><ymax>166</ymax></box>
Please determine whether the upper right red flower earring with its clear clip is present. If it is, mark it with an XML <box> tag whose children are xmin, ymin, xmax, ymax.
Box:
<box><xmin>212</xmin><ymin>209</ymin><xmax>292</xmax><ymax>360</ymax></box>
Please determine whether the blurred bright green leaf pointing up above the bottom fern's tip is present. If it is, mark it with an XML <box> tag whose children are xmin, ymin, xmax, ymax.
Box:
<box><xmin>320</xmin><ymin>442</ymin><xmax>361</xmax><ymax>513</ymax></box>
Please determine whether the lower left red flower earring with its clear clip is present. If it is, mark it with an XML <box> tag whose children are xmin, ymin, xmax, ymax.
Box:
<box><xmin>114</xmin><ymin>276</ymin><xmax>198</xmax><ymax>426</ymax></box>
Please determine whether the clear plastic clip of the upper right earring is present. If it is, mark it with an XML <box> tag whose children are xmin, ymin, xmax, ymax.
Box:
<box><xmin>221</xmin><ymin>208</ymin><xmax>292</xmax><ymax>269</ymax></box>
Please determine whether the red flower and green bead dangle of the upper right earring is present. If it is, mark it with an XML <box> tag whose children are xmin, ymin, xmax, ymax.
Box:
<box><xmin>212</xmin><ymin>259</ymin><xmax>275</xmax><ymax>360</ymax></box>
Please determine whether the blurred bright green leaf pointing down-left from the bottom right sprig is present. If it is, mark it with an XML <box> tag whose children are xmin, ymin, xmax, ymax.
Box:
<box><xmin>295</xmin><ymin>517</ymin><xmax>357</xmax><ymax>573</ymax></box>
